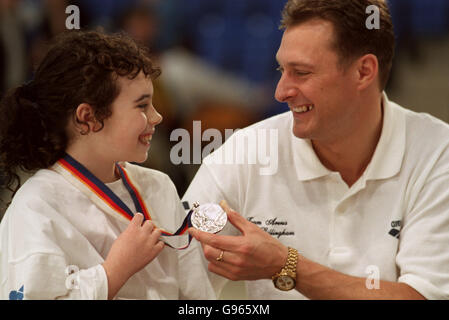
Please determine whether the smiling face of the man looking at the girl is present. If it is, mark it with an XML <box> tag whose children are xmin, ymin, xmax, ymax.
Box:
<box><xmin>275</xmin><ymin>19</ymin><xmax>359</xmax><ymax>141</ymax></box>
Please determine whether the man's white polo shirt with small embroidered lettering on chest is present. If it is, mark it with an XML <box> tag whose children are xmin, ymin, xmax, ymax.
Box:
<box><xmin>183</xmin><ymin>95</ymin><xmax>449</xmax><ymax>299</ymax></box>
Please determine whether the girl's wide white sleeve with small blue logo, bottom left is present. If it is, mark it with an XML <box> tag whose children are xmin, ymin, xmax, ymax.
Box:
<box><xmin>0</xmin><ymin>189</ymin><xmax>108</xmax><ymax>300</ymax></box>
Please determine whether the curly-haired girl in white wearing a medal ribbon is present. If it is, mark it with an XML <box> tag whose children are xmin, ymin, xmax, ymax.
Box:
<box><xmin>0</xmin><ymin>32</ymin><xmax>215</xmax><ymax>299</ymax></box>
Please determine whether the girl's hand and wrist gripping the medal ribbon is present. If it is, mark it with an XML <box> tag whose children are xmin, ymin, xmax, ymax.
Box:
<box><xmin>103</xmin><ymin>213</ymin><xmax>164</xmax><ymax>299</ymax></box>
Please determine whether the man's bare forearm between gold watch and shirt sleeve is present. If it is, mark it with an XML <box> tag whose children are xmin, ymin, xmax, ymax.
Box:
<box><xmin>296</xmin><ymin>255</ymin><xmax>425</xmax><ymax>300</ymax></box>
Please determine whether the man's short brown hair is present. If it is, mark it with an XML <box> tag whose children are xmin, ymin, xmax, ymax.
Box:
<box><xmin>280</xmin><ymin>0</ymin><xmax>395</xmax><ymax>91</ymax></box>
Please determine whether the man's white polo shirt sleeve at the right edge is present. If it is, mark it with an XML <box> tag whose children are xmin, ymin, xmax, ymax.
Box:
<box><xmin>396</xmin><ymin>162</ymin><xmax>449</xmax><ymax>299</ymax></box>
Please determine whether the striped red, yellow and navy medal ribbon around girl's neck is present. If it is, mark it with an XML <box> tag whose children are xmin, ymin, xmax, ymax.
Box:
<box><xmin>53</xmin><ymin>154</ymin><xmax>192</xmax><ymax>249</ymax></box>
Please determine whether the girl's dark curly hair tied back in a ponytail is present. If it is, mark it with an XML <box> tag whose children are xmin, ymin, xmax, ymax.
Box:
<box><xmin>0</xmin><ymin>31</ymin><xmax>160</xmax><ymax>200</ymax></box>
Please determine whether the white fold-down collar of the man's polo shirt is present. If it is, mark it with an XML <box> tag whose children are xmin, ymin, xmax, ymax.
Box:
<box><xmin>290</xmin><ymin>93</ymin><xmax>405</xmax><ymax>181</ymax></box>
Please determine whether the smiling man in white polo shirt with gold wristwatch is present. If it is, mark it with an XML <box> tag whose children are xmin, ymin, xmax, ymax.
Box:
<box><xmin>183</xmin><ymin>0</ymin><xmax>449</xmax><ymax>299</ymax></box>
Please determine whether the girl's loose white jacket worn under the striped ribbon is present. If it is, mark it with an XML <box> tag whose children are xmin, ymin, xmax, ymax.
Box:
<box><xmin>0</xmin><ymin>163</ymin><xmax>215</xmax><ymax>300</ymax></box>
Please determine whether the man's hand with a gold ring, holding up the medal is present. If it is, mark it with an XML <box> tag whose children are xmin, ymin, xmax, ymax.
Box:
<box><xmin>189</xmin><ymin>201</ymin><xmax>288</xmax><ymax>281</ymax></box>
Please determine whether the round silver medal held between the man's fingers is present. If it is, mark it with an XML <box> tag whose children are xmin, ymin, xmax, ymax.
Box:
<box><xmin>190</xmin><ymin>202</ymin><xmax>228</xmax><ymax>233</ymax></box>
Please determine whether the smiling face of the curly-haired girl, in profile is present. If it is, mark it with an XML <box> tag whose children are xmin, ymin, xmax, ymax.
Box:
<box><xmin>94</xmin><ymin>73</ymin><xmax>162</xmax><ymax>163</ymax></box>
